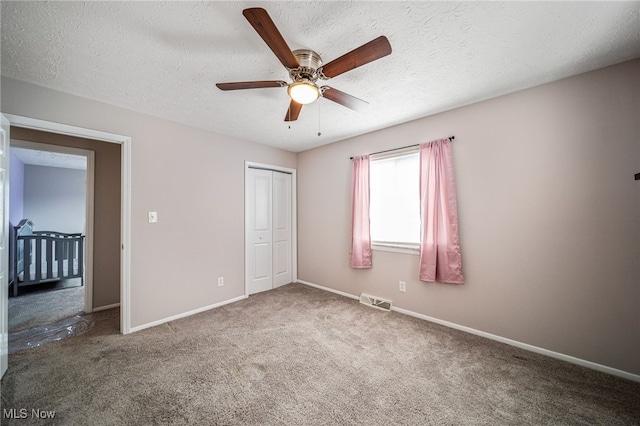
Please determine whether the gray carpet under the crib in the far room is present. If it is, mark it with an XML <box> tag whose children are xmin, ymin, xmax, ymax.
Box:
<box><xmin>9</xmin><ymin>278</ymin><xmax>84</xmax><ymax>332</ymax></box>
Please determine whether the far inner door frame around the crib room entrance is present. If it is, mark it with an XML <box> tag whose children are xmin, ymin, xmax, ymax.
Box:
<box><xmin>10</xmin><ymin>140</ymin><xmax>95</xmax><ymax>314</ymax></box>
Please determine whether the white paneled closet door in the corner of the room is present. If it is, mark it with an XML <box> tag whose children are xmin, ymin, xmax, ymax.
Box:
<box><xmin>245</xmin><ymin>168</ymin><xmax>292</xmax><ymax>294</ymax></box>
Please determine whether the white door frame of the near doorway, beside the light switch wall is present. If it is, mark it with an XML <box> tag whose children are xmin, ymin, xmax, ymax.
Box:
<box><xmin>4</xmin><ymin>114</ymin><xmax>131</xmax><ymax>334</ymax></box>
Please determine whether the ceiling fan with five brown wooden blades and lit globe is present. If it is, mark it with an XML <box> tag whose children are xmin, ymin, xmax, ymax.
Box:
<box><xmin>216</xmin><ymin>8</ymin><xmax>391</xmax><ymax>121</ymax></box>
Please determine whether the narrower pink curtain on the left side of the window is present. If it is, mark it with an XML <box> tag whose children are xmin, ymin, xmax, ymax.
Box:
<box><xmin>349</xmin><ymin>155</ymin><xmax>371</xmax><ymax>269</ymax></box>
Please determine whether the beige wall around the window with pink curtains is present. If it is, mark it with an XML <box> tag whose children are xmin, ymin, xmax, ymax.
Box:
<box><xmin>298</xmin><ymin>60</ymin><xmax>640</xmax><ymax>374</ymax></box>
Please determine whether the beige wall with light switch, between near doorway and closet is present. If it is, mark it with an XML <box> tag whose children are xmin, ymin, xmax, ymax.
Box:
<box><xmin>1</xmin><ymin>77</ymin><xmax>296</xmax><ymax>327</ymax></box>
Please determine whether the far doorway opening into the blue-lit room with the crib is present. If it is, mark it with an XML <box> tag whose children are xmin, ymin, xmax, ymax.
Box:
<box><xmin>9</xmin><ymin>139</ymin><xmax>95</xmax><ymax>332</ymax></box>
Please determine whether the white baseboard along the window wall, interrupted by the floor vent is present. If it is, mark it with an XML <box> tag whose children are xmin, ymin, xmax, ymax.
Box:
<box><xmin>298</xmin><ymin>280</ymin><xmax>640</xmax><ymax>382</ymax></box>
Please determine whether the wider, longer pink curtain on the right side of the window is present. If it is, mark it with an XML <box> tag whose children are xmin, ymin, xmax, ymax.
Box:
<box><xmin>420</xmin><ymin>139</ymin><xmax>464</xmax><ymax>284</ymax></box>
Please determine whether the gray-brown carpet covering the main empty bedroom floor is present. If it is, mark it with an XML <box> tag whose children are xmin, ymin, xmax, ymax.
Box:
<box><xmin>2</xmin><ymin>284</ymin><xmax>640</xmax><ymax>425</ymax></box>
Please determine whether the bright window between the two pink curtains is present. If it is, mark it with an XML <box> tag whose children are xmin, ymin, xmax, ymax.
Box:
<box><xmin>369</xmin><ymin>149</ymin><xmax>420</xmax><ymax>250</ymax></box>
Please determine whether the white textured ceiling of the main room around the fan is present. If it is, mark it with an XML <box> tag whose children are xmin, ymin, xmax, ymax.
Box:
<box><xmin>0</xmin><ymin>1</ymin><xmax>640</xmax><ymax>152</ymax></box>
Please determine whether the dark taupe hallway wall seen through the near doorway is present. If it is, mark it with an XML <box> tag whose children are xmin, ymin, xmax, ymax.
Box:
<box><xmin>11</xmin><ymin>127</ymin><xmax>120</xmax><ymax>308</ymax></box>
